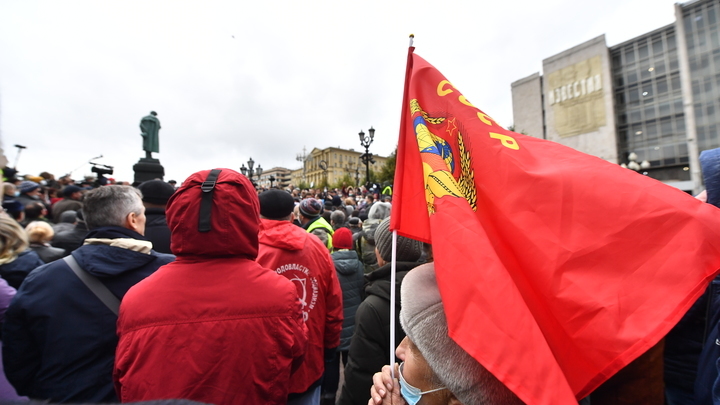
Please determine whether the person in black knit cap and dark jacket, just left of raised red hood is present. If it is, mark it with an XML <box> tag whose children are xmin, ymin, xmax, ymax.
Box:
<box><xmin>138</xmin><ymin>180</ymin><xmax>175</xmax><ymax>253</ymax></box>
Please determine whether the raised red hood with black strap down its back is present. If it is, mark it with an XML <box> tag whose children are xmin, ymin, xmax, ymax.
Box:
<box><xmin>166</xmin><ymin>169</ymin><xmax>260</xmax><ymax>260</ymax></box>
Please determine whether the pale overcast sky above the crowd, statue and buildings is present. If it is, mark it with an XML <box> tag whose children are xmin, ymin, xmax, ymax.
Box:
<box><xmin>0</xmin><ymin>0</ymin><xmax>674</xmax><ymax>181</ymax></box>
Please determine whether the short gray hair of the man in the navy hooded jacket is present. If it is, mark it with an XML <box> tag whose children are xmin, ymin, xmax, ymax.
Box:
<box><xmin>83</xmin><ymin>185</ymin><xmax>143</xmax><ymax>229</ymax></box>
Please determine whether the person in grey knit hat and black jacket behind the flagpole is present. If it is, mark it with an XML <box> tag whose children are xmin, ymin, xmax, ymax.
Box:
<box><xmin>338</xmin><ymin>217</ymin><xmax>423</xmax><ymax>405</ymax></box>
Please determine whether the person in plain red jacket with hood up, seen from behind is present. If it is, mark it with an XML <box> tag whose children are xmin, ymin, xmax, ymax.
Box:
<box><xmin>113</xmin><ymin>169</ymin><xmax>307</xmax><ymax>405</ymax></box>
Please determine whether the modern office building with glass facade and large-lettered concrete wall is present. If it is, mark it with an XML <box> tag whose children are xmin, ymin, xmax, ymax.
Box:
<box><xmin>512</xmin><ymin>0</ymin><xmax>720</xmax><ymax>192</ymax></box>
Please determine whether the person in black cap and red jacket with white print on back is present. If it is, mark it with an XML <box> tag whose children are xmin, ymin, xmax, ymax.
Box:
<box><xmin>257</xmin><ymin>189</ymin><xmax>343</xmax><ymax>405</ymax></box>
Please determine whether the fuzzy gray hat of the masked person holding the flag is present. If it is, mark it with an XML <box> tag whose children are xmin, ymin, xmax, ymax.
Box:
<box><xmin>400</xmin><ymin>263</ymin><xmax>523</xmax><ymax>405</ymax></box>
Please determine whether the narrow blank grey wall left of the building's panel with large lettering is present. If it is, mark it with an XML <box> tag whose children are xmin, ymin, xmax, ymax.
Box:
<box><xmin>510</xmin><ymin>73</ymin><xmax>545</xmax><ymax>139</ymax></box>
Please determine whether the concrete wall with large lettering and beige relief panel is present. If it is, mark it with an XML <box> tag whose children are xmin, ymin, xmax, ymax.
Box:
<box><xmin>540</xmin><ymin>35</ymin><xmax>618</xmax><ymax>163</ymax></box>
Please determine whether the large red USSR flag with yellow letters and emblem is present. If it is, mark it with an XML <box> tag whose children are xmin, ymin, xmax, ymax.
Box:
<box><xmin>391</xmin><ymin>48</ymin><xmax>720</xmax><ymax>405</ymax></box>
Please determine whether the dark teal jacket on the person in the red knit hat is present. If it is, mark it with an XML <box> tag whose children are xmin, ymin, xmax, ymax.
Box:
<box><xmin>332</xmin><ymin>250</ymin><xmax>365</xmax><ymax>351</ymax></box>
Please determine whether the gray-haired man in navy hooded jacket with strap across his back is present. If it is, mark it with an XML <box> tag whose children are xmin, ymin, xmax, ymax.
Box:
<box><xmin>2</xmin><ymin>186</ymin><xmax>174</xmax><ymax>402</ymax></box>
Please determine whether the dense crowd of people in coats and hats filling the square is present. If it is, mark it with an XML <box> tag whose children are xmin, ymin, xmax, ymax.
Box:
<box><xmin>0</xmin><ymin>165</ymin><xmax>714</xmax><ymax>405</ymax></box>
